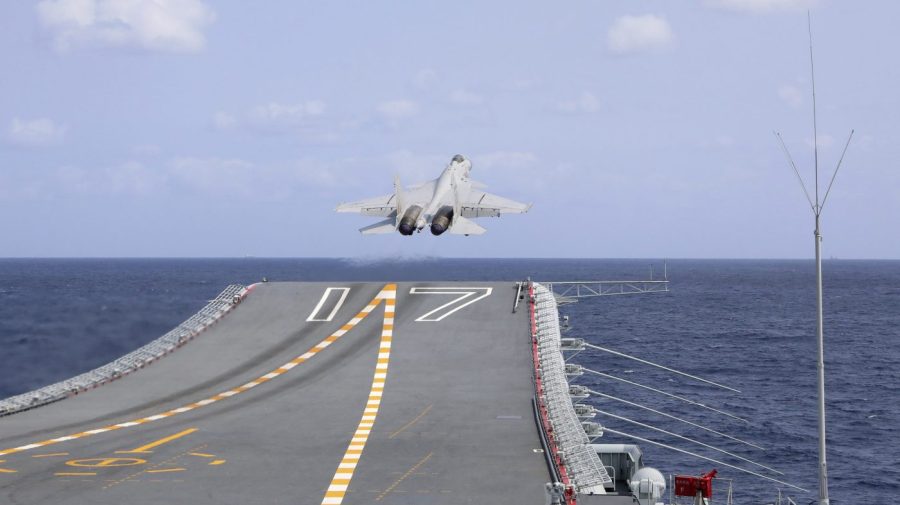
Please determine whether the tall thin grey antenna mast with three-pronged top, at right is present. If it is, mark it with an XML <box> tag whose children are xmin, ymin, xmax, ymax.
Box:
<box><xmin>775</xmin><ymin>11</ymin><xmax>853</xmax><ymax>505</ymax></box>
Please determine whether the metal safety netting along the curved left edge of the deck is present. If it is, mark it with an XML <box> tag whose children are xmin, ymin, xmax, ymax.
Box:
<box><xmin>0</xmin><ymin>284</ymin><xmax>248</xmax><ymax>417</ymax></box>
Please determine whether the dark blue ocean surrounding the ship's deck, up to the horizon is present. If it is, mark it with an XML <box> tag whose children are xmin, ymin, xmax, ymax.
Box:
<box><xmin>0</xmin><ymin>258</ymin><xmax>900</xmax><ymax>504</ymax></box>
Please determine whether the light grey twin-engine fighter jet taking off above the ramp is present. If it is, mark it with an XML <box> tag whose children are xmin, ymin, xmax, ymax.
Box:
<box><xmin>335</xmin><ymin>154</ymin><xmax>531</xmax><ymax>236</ymax></box>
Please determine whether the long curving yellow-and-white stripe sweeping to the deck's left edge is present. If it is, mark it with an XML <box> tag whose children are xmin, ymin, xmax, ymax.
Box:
<box><xmin>0</xmin><ymin>284</ymin><xmax>397</xmax><ymax>456</ymax></box>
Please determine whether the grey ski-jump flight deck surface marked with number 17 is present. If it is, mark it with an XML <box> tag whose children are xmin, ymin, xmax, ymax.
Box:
<box><xmin>0</xmin><ymin>283</ymin><xmax>549</xmax><ymax>505</ymax></box>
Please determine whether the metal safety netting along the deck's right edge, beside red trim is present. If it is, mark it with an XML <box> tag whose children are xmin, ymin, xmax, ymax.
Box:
<box><xmin>534</xmin><ymin>283</ymin><xmax>613</xmax><ymax>494</ymax></box>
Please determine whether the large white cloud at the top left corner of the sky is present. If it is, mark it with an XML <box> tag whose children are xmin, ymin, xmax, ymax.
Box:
<box><xmin>37</xmin><ymin>0</ymin><xmax>215</xmax><ymax>52</ymax></box>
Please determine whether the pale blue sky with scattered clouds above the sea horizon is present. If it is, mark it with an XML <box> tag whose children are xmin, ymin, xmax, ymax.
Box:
<box><xmin>0</xmin><ymin>0</ymin><xmax>900</xmax><ymax>258</ymax></box>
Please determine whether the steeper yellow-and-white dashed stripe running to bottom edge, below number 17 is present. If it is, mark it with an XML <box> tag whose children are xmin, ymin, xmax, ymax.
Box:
<box><xmin>322</xmin><ymin>284</ymin><xmax>397</xmax><ymax>505</ymax></box>
